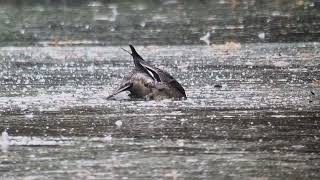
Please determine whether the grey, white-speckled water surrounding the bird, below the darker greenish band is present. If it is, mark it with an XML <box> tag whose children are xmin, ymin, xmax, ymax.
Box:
<box><xmin>0</xmin><ymin>43</ymin><xmax>320</xmax><ymax>179</ymax></box>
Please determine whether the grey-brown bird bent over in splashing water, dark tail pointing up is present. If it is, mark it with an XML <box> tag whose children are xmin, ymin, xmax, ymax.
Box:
<box><xmin>107</xmin><ymin>45</ymin><xmax>187</xmax><ymax>100</ymax></box>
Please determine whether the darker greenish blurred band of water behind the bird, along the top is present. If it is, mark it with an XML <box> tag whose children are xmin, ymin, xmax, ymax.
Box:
<box><xmin>0</xmin><ymin>0</ymin><xmax>320</xmax><ymax>46</ymax></box>
